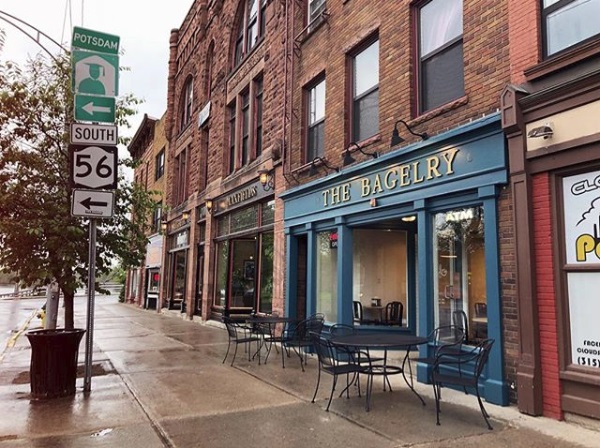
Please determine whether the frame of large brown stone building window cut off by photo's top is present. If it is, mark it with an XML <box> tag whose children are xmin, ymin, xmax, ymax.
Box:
<box><xmin>231</xmin><ymin>0</ymin><xmax>267</xmax><ymax>70</ymax></box>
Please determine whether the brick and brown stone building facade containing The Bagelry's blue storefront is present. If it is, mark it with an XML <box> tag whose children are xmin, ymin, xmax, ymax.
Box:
<box><xmin>161</xmin><ymin>0</ymin><xmax>520</xmax><ymax>410</ymax></box>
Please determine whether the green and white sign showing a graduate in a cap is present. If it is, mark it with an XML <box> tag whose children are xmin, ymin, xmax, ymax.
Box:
<box><xmin>72</xmin><ymin>50</ymin><xmax>119</xmax><ymax>96</ymax></box>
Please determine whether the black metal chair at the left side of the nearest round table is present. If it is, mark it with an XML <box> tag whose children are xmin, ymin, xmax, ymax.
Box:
<box><xmin>311</xmin><ymin>333</ymin><xmax>366</xmax><ymax>412</ymax></box>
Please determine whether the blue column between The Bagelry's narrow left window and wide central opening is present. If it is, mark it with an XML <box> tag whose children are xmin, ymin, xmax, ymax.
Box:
<box><xmin>335</xmin><ymin>217</ymin><xmax>353</xmax><ymax>325</ymax></box>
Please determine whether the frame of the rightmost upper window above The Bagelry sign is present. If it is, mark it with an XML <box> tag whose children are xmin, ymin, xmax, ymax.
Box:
<box><xmin>415</xmin><ymin>0</ymin><xmax>465</xmax><ymax>115</ymax></box>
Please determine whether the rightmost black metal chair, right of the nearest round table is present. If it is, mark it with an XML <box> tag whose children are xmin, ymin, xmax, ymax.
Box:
<box><xmin>431</xmin><ymin>339</ymin><xmax>494</xmax><ymax>430</ymax></box>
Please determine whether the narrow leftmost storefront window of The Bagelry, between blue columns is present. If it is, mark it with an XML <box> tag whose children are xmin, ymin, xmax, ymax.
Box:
<box><xmin>316</xmin><ymin>232</ymin><xmax>338</xmax><ymax>322</ymax></box>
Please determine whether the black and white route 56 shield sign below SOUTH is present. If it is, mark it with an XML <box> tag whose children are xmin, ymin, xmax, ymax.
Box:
<box><xmin>69</xmin><ymin>145</ymin><xmax>118</xmax><ymax>190</ymax></box>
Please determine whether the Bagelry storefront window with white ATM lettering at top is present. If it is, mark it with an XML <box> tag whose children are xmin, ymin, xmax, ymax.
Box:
<box><xmin>433</xmin><ymin>207</ymin><xmax>488</xmax><ymax>344</ymax></box>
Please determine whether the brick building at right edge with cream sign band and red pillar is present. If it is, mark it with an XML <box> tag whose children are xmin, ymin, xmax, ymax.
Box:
<box><xmin>501</xmin><ymin>0</ymin><xmax>600</xmax><ymax>419</ymax></box>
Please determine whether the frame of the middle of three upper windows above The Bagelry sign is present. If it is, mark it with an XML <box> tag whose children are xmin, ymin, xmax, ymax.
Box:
<box><xmin>348</xmin><ymin>38</ymin><xmax>381</xmax><ymax>142</ymax></box>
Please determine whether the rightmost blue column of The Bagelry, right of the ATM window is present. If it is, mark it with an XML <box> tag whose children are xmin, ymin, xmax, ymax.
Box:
<box><xmin>479</xmin><ymin>186</ymin><xmax>508</xmax><ymax>406</ymax></box>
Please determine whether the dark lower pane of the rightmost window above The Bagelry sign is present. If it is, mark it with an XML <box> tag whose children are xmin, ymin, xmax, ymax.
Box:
<box><xmin>421</xmin><ymin>41</ymin><xmax>465</xmax><ymax>111</ymax></box>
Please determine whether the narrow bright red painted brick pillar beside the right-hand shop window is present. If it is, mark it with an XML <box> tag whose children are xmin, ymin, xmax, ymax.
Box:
<box><xmin>532</xmin><ymin>173</ymin><xmax>562</xmax><ymax>419</ymax></box>
